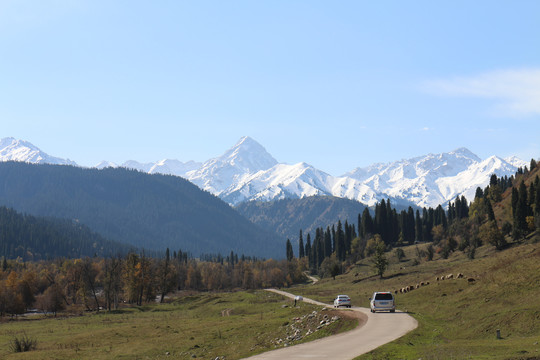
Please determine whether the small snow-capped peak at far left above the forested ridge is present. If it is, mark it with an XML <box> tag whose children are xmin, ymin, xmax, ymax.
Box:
<box><xmin>0</xmin><ymin>137</ymin><xmax>77</xmax><ymax>166</ymax></box>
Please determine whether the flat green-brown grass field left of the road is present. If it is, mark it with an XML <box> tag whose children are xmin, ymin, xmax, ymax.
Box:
<box><xmin>0</xmin><ymin>291</ymin><xmax>356</xmax><ymax>359</ymax></box>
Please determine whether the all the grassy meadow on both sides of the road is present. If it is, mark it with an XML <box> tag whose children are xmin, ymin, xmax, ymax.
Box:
<box><xmin>4</xmin><ymin>239</ymin><xmax>540</xmax><ymax>360</ymax></box>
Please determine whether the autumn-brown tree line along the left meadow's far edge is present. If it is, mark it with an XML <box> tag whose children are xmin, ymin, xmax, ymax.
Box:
<box><xmin>0</xmin><ymin>249</ymin><xmax>305</xmax><ymax>316</ymax></box>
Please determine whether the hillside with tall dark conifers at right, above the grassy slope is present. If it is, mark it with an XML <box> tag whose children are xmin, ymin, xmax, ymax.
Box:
<box><xmin>292</xmin><ymin>160</ymin><xmax>540</xmax><ymax>276</ymax></box>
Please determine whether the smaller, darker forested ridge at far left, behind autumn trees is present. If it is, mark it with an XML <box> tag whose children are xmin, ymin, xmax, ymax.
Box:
<box><xmin>0</xmin><ymin>206</ymin><xmax>135</xmax><ymax>260</ymax></box>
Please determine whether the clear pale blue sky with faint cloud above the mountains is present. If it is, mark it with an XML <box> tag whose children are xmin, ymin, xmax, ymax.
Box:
<box><xmin>0</xmin><ymin>0</ymin><xmax>540</xmax><ymax>175</ymax></box>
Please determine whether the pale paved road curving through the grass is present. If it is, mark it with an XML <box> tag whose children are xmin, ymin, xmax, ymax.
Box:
<box><xmin>247</xmin><ymin>289</ymin><xmax>418</xmax><ymax>360</ymax></box>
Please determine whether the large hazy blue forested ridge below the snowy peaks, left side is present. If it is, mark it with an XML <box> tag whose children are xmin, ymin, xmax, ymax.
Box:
<box><xmin>0</xmin><ymin>162</ymin><xmax>283</xmax><ymax>258</ymax></box>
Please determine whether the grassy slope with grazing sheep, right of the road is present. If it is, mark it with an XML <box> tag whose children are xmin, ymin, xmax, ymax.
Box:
<box><xmin>296</xmin><ymin>238</ymin><xmax>540</xmax><ymax>360</ymax></box>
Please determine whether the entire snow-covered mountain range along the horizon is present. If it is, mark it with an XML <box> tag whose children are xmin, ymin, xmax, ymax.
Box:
<box><xmin>0</xmin><ymin>136</ymin><xmax>527</xmax><ymax>207</ymax></box>
